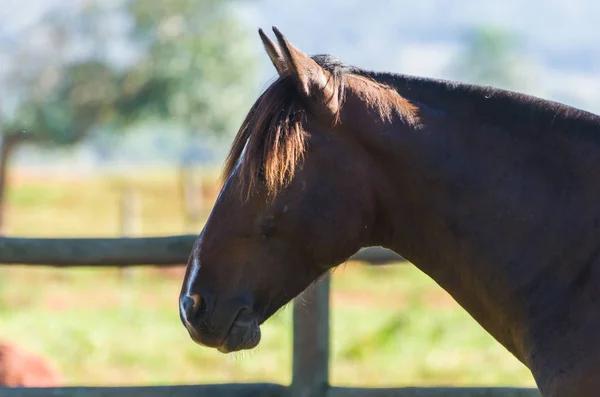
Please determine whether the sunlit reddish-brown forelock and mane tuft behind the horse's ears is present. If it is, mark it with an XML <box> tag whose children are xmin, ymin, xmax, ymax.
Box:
<box><xmin>222</xmin><ymin>55</ymin><xmax>418</xmax><ymax>197</ymax></box>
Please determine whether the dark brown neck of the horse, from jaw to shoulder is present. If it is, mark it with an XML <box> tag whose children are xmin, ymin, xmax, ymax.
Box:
<box><xmin>340</xmin><ymin>70</ymin><xmax>600</xmax><ymax>360</ymax></box>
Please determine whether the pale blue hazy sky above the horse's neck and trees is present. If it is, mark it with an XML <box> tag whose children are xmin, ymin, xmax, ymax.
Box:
<box><xmin>0</xmin><ymin>0</ymin><xmax>600</xmax><ymax>169</ymax></box>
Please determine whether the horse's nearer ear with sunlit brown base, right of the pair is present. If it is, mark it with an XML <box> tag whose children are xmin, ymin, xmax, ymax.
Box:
<box><xmin>273</xmin><ymin>26</ymin><xmax>340</xmax><ymax>115</ymax></box>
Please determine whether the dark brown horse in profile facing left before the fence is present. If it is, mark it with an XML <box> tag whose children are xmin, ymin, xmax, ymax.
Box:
<box><xmin>180</xmin><ymin>28</ymin><xmax>600</xmax><ymax>397</ymax></box>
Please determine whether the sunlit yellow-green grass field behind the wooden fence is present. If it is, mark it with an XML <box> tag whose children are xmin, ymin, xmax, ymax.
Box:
<box><xmin>0</xmin><ymin>167</ymin><xmax>534</xmax><ymax>386</ymax></box>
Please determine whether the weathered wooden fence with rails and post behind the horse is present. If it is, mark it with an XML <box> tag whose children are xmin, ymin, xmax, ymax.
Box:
<box><xmin>0</xmin><ymin>236</ymin><xmax>540</xmax><ymax>397</ymax></box>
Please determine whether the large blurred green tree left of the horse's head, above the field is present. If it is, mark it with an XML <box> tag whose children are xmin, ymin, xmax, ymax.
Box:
<box><xmin>0</xmin><ymin>0</ymin><xmax>254</xmax><ymax>227</ymax></box>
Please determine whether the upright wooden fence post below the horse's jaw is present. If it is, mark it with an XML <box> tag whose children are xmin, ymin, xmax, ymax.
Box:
<box><xmin>290</xmin><ymin>274</ymin><xmax>331</xmax><ymax>397</ymax></box>
